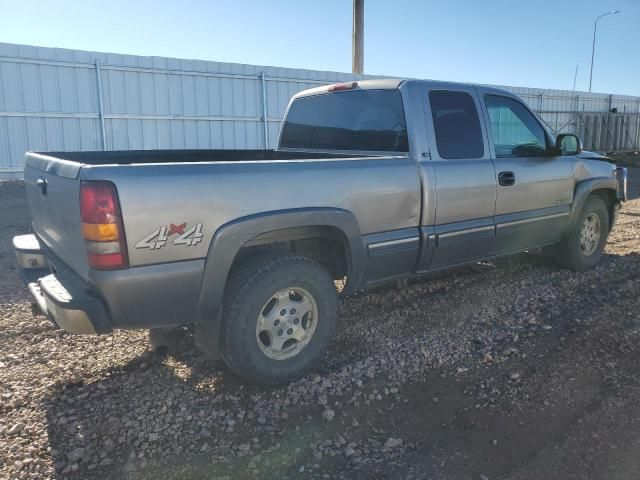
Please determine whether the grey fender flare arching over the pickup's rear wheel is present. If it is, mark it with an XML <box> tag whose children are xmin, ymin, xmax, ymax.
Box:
<box><xmin>195</xmin><ymin>207</ymin><xmax>366</xmax><ymax>357</ymax></box>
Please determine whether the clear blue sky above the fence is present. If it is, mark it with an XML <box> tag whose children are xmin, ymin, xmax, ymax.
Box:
<box><xmin>0</xmin><ymin>0</ymin><xmax>640</xmax><ymax>96</ymax></box>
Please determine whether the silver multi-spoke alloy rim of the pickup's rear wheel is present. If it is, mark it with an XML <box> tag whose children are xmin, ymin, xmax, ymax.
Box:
<box><xmin>256</xmin><ymin>288</ymin><xmax>318</xmax><ymax>360</ymax></box>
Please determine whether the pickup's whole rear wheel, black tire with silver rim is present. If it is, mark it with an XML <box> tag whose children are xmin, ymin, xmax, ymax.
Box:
<box><xmin>222</xmin><ymin>255</ymin><xmax>338</xmax><ymax>385</ymax></box>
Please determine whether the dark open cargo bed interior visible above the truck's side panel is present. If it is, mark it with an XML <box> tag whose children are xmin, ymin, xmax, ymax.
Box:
<box><xmin>33</xmin><ymin>150</ymin><xmax>356</xmax><ymax>165</ymax></box>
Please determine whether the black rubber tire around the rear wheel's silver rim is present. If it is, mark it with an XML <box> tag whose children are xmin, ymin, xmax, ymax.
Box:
<box><xmin>221</xmin><ymin>255</ymin><xmax>338</xmax><ymax>386</ymax></box>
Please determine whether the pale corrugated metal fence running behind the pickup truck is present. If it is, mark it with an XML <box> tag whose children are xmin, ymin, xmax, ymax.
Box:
<box><xmin>0</xmin><ymin>43</ymin><xmax>640</xmax><ymax>179</ymax></box>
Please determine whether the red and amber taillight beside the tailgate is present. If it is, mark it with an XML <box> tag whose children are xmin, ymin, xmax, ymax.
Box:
<box><xmin>80</xmin><ymin>180</ymin><xmax>129</xmax><ymax>270</ymax></box>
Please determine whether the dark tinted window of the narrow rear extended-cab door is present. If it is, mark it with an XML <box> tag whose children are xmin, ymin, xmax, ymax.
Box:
<box><xmin>429</xmin><ymin>90</ymin><xmax>484</xmax><ymax>160</ymax></box>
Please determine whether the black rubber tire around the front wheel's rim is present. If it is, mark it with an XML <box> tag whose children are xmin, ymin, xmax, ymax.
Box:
<box><xmin>557</xmin><ymin>195</ymin><xmax>609</xmax><ymax>271</ymax></box>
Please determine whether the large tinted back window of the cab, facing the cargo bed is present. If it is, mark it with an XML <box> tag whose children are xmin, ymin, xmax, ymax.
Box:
<box><xmin>280</xmin><ymin>90</ymin><xmax>409</xmax><ymax>152</ymax></box>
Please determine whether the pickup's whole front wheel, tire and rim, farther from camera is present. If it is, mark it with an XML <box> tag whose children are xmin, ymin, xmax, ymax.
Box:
<box><xmin>558</xmin><ymin>195</ymin><xmax>609</xmax><ymax>271</ymax></box>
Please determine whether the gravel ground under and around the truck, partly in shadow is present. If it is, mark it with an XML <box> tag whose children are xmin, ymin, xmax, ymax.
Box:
<box><xmin>0</xmin><ymin>169</ymin><xmax>640</xmax><ymax>480</ymax></box>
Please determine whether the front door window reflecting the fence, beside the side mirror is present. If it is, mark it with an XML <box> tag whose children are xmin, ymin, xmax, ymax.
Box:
<box><xmin>484</xmin><ymin>95</ymin><xmax>547</xmax><ymax>157</ymax></box>
